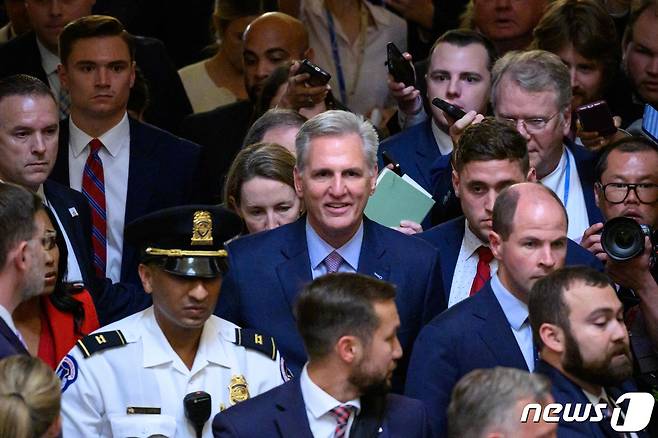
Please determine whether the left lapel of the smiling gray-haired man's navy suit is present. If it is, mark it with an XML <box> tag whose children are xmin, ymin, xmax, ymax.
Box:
<box><xmin>276</xmin><ymin>216</ymin><xmax>313</xmax><ymax>309</ymax></box>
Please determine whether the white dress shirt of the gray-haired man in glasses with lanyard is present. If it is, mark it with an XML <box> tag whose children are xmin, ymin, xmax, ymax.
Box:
<box><xmin>541</xmin><ymin>147</ymin><xmax>589</xmax><ymax>243</ymax></box>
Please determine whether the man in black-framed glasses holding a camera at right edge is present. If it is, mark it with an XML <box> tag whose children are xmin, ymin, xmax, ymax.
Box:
<box><xmin>581</xmin><ymin>136</ymin><xmax>658</xmax><ymax>404</ymax></box>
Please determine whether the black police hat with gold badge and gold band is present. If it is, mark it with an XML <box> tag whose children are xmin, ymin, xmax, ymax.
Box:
<box><xmin>125</xmin><ymin>205</ymin><xmax>242</xmax><ymax>278</ymax></box>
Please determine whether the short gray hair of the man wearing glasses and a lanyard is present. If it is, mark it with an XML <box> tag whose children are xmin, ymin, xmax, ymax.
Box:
<box><xmin>491</xmin><ymin>50</ymin><xmax>571</xmax><ymax>112</ymax></box>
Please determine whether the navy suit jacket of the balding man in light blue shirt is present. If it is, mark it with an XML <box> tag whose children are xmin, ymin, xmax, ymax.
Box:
<box><xmin>405</xmin><ymin>282</ymin><xmax>528</xmax><ymax>436</ymax></box>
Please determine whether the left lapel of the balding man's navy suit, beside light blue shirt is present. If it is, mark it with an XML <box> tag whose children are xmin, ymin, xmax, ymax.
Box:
<box><xmin>473</xmin><ymin>282</ymin><xmax>528</xmax><ymax>371</ymax></box>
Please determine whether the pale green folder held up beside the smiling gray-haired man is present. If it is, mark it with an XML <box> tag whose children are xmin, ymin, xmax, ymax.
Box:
<box><xmin>365</xmin><ymin>168</ymin><xmax>434</xmax><ymax>227</ymax></box>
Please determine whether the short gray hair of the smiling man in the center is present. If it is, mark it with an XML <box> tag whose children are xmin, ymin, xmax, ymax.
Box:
<box><xmin>295</xmin><ymin>110</ymin><xmax>379</xmax><ymax>172</ymax></box>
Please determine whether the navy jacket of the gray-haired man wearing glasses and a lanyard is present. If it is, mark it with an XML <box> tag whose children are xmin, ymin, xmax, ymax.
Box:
<box><xmin>429</xmin><ymin>138</ymin><xmax>603</xmax><ymax>225</ymax></box>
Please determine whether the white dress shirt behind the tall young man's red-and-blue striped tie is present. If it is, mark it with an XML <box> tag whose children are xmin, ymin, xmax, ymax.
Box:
<box><xmin>69</xmin><ymin>113</ymin><xmax>130</xmax><ymax>282</ymax></box>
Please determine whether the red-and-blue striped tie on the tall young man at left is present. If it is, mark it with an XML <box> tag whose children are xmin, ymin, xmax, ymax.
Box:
<box><xmin>82</xmin><ymin>138</ymin><xmax>107</xmax><ymax>278</ymax></box>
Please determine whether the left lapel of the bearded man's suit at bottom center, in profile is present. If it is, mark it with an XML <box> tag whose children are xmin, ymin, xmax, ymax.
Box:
<box><xmin>274</xmin><ymin>379</ymin><xmax>313</xmax><ymax>438</ymax></box>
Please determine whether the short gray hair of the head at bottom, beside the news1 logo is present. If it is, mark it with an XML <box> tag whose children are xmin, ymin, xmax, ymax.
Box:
<box><xmin>448</xmin><ymin>367</ymin><xmax>551</xmax><ymax>438</ymax></box>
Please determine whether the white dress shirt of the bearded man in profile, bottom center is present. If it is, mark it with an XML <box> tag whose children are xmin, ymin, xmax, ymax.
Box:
<box><xmin>299</xmin><ymin>365</ymin><xmax>361</xmax><ymax>438</ymax></box>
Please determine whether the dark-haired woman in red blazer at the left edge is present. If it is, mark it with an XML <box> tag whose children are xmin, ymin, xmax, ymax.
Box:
<box><xmin>12</xmin><ymin>208</ymin><xmax>99</xmax><ymax>369</ymax></box>
